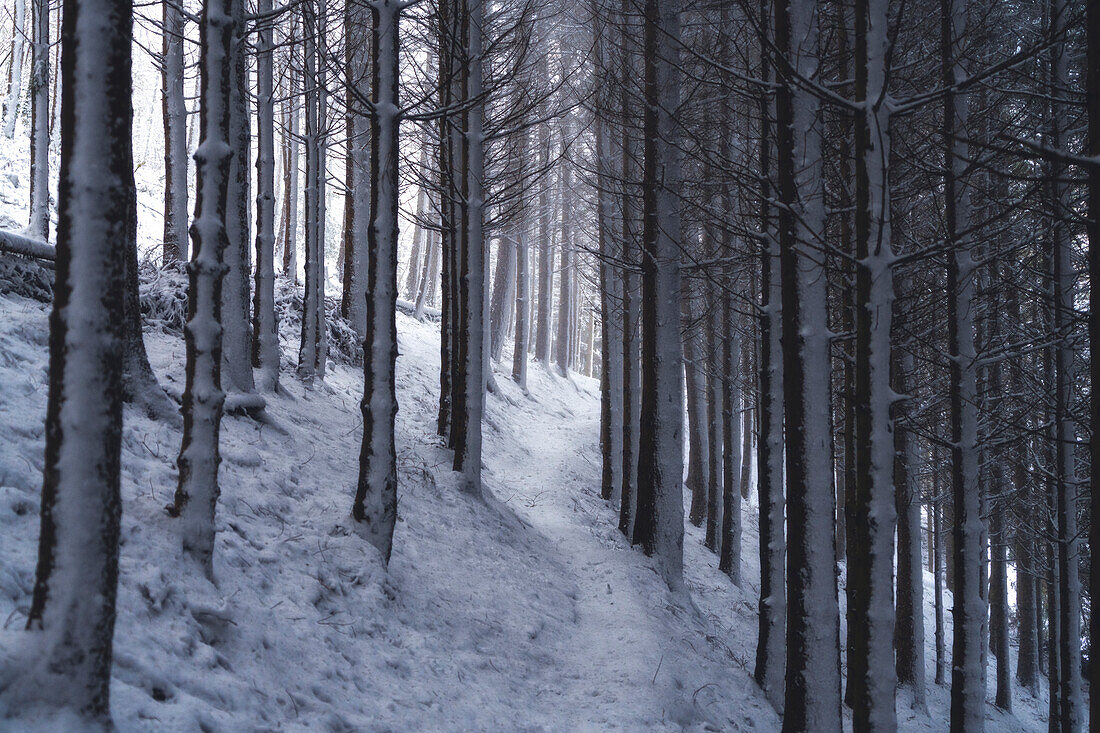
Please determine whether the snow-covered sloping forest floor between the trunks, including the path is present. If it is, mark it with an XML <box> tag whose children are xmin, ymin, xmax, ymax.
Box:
<box><xmin>0</xmin><ymin>275</ymin><xmax>1060</xmax><ymax>732</ymax></box>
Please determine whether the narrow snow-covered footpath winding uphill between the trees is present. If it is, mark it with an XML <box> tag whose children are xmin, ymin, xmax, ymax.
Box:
<box><xmin>477</xmin><ymin>372</ymin><xmax>778</xmax><ymax>731</ymax></box>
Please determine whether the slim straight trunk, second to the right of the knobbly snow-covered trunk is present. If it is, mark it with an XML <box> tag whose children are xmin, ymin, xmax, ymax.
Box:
<box><xmin>252</xmin><ymin>0</ymin><xmax>281</xmax><ymax>392</ymax></box>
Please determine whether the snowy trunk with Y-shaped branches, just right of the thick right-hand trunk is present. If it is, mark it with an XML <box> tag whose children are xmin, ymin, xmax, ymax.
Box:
<box><xmin>845</xmin><ymin>0</ymin><xmax>898</xmax><ymax>717</ymax></box>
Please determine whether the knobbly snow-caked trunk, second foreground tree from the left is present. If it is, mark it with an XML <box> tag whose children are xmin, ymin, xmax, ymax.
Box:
<box><xmin>169</xmin><ymin>0</ymin><xmax>238</xmax><ymax>578</ymax></box>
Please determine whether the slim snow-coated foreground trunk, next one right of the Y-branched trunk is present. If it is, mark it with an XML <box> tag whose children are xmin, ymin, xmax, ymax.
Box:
<box><xmin>941</xmin><ymin>0</ymin><xmax>987</xmax><ymax>731</ymax></box>
